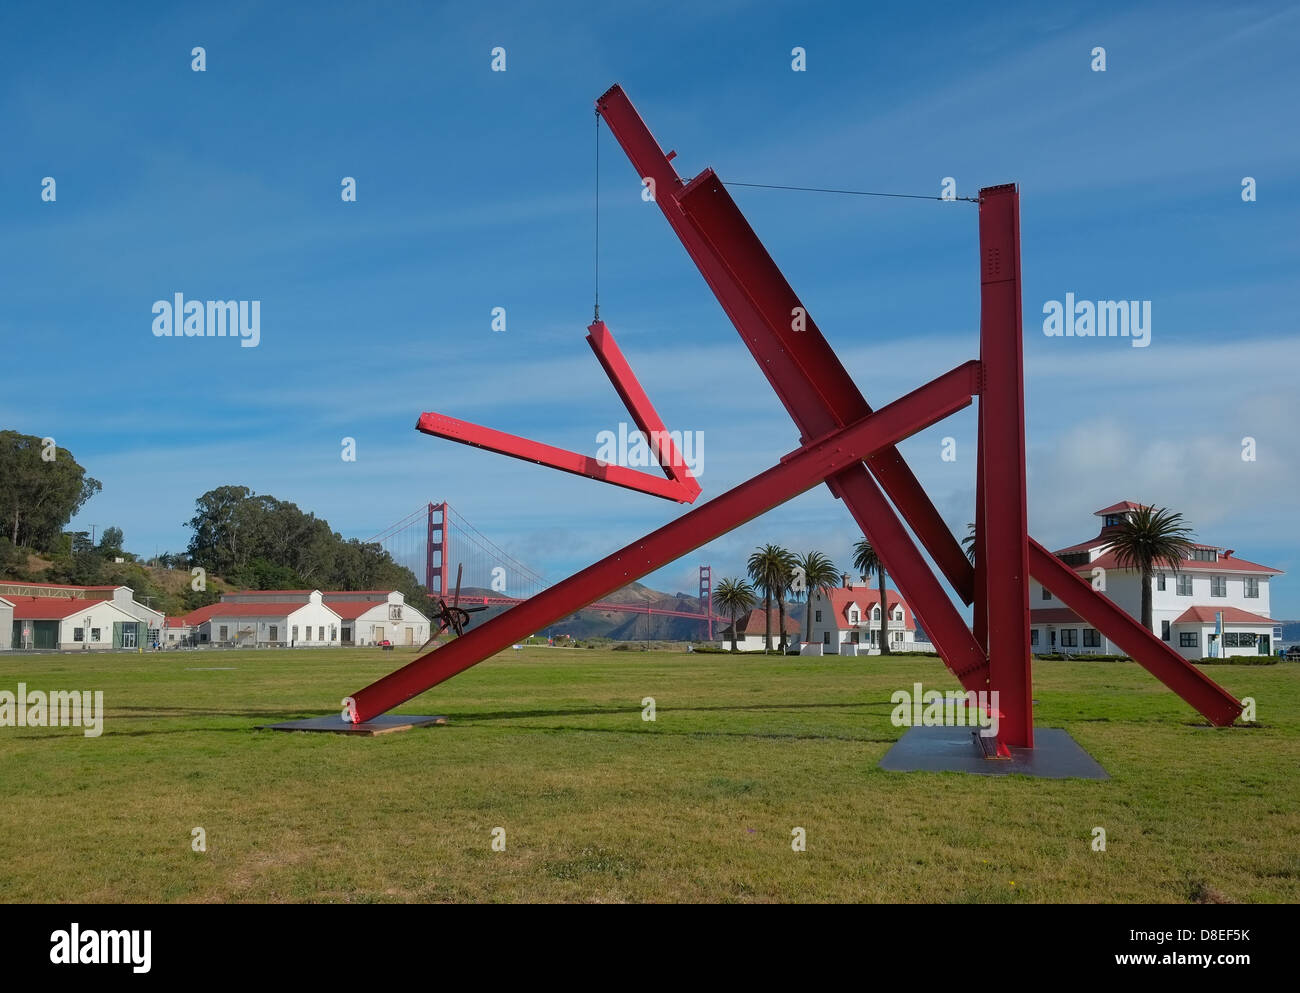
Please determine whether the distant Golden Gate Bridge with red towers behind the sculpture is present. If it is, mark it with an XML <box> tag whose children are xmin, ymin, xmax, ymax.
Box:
<box><xmin>367</xmin><ymin>500</ymin><xmax>728</xmax><ymax>641</ymax></box>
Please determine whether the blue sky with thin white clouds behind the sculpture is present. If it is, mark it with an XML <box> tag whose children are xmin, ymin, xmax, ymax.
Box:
<box><xmin>0</xmin><ymin>3</ymin><xmax>1300</xmax><ymax>617</ymax></box>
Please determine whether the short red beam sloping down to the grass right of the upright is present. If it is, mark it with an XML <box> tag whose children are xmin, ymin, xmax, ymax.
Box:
<box><xmin>1030</xmin><ymin>538</ymin><xmax>1242</xmax><ymax>727</ymax></box>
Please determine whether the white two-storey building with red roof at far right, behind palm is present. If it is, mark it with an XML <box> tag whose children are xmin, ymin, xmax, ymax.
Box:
<box><xmin>1030</xmin><ymin>500</ymin><xmax>1282</xmax><ymax>659</ymax></box>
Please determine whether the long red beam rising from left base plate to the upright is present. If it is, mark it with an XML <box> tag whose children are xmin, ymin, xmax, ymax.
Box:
<box><xmin>351</xmin><ymin>361</ymin><xmax>987</xmax><ymax>723</ymax></box>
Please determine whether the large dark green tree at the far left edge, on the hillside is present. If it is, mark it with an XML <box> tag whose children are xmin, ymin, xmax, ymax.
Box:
<box><xmin>0</xmin><ymin>432</ymin><xmax>103</xmax><ymax>551</ymax></box>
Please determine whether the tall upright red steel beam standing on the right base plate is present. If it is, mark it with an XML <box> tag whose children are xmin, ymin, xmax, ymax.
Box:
<box><xmin>976</xmin><ymin>185</ymin><xmax>1034</xmax><ymax>749</ymax></box>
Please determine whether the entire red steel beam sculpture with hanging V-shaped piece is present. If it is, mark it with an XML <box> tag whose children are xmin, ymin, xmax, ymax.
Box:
<box><xmin>350</xmin><ymin>86</ymin><xmax>1242</xmax><ymax>755</ymax></box>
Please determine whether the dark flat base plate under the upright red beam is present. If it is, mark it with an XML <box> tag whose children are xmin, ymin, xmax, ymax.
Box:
<box><xmin>880</xmin><ymin>728</ymin><xmax>1110</xmax><ymax>780</ymax></box>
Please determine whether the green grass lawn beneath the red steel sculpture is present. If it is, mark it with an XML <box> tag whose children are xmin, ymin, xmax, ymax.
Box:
<box><xmin>0</xmin><ymin>649</ymin><xmax>1300</xmax><ymax>902</ymax></box>
